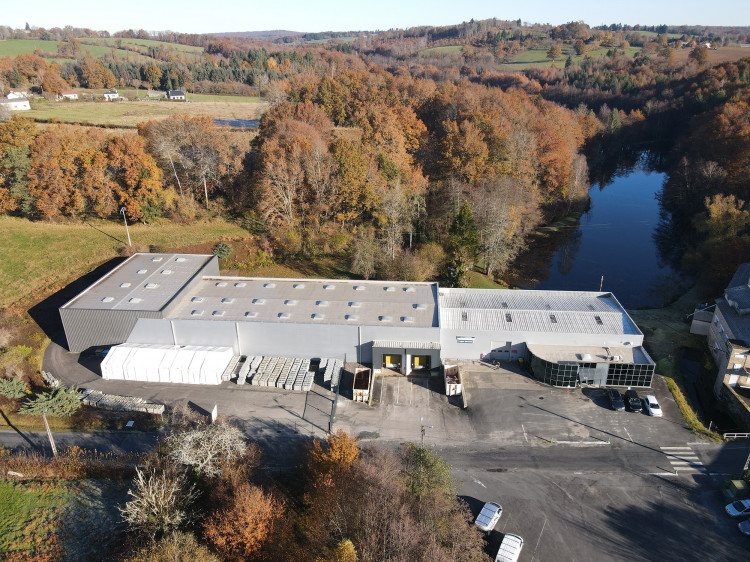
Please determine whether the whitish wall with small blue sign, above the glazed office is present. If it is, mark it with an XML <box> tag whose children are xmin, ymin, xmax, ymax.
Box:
<box><xmin>440</xmin><ymin>328</ymin><xmax>643</xmax><ymax>360</ymax></box>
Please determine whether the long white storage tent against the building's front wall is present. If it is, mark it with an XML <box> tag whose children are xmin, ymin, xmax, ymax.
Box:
<box><xmin>102</xmin><ymin>343</ymin><xmax>233</xmax><ymax>384</ymax></box>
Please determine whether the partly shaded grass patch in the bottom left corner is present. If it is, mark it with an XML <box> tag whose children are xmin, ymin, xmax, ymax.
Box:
<box><xmin>0</xmin><ymin>480</ymin><xmax>127</xmax><ymax>560</ymax></box>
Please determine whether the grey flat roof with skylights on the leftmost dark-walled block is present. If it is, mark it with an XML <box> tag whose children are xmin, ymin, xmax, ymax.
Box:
<box><xmin>61</xmin><ymin>253</ymin><xmax>214</xmax><ymax>311</ymax></box>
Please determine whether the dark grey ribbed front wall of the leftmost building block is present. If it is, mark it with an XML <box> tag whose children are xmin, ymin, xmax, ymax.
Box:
<box><xmin>60</xmin><ymin>308</ymin><xmax>161</xmax><ymax>353</ymax></box>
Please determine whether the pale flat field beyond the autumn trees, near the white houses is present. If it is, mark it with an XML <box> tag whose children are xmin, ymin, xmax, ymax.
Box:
<box><xmin>24</xmin><ymin>97</ymin><xmax>268</xmax><ymax>127</ymax></box>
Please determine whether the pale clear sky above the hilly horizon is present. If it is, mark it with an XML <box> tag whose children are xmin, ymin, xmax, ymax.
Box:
<box><xmin>0</xmin><ymin>0</ymin><xmax>750</xmax><ymax>33</ymax></box>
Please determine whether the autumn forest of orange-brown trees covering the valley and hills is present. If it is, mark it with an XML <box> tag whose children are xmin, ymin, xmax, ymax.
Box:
<box><xmin>0</xmin><ymin>20</ymin><xmax>750</xmax><ymax>285</ymax></box>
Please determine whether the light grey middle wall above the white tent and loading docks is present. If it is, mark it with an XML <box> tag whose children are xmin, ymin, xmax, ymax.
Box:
<box><xmin>125</xmin><ymin>319</ymin><xmax>439</xmax><ymax>363</ymax></box>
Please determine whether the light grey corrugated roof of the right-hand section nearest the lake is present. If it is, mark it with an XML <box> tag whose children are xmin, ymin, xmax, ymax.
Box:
<box><xmin>439</xmin><ymin>289</ymin><xmax>641</xmax><ymax>335</ymax></box>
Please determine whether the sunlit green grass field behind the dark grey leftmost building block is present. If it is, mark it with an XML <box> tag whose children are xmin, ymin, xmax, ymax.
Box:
<box><xmin>0</xmin><ymin>216</ymin><xmax>247</xmax><ymax>308</ymax></box>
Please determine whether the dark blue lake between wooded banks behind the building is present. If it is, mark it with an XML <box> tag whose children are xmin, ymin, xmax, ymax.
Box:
<box><xmin>511</xmin><ymin>160</ymin><xmax>684</xmax><ymax>308</ymax></box>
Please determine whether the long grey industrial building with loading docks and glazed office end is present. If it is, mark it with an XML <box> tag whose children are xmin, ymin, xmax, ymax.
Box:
<box><xmin>60</xmin><ymin>254</ymin><xmax>654</xmax><ymax>387</ymax></box>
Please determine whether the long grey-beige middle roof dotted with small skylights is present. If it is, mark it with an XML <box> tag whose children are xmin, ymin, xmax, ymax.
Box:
<box><xmin>167</xmin><ymin>277</ymin><xmax>437</xmax><ymax>327</ymax></box>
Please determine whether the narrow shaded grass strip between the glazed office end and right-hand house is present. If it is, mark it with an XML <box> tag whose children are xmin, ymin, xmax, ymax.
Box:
<box><xmin>628</xmin><ymin>287</ymin><xmax>721</xmax><ymax>440</ymax></box>
